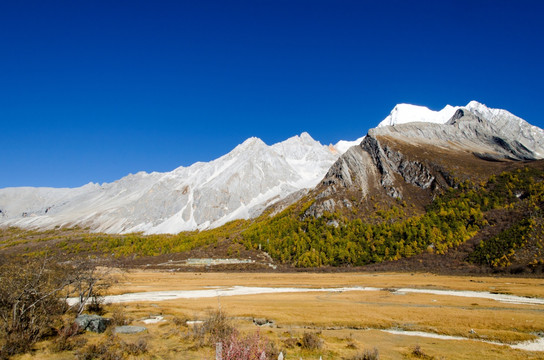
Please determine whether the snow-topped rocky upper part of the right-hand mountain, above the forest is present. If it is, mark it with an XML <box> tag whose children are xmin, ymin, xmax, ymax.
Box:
<box><xmin>307</xmin><ymin>101</ymin><xmax>544</xmax><ymax>216</ymax></box>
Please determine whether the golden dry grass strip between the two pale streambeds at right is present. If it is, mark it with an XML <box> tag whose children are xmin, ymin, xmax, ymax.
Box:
<box><xmin>135</xmin><ymin>291</ymin><xmax>544</xmax><ymax>342</ymax></box>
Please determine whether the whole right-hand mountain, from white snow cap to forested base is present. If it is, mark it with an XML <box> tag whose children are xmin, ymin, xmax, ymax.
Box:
<box><xmin>241</xmin><ymin>102</ymin><xmax>544</xmax><ymax>274</ymax></box>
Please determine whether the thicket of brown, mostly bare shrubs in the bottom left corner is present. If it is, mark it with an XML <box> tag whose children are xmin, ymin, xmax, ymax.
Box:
<box><xmin>0</xmin><ymin>258</ymin><xmax>111</xmax><ymax>359</ymax></box>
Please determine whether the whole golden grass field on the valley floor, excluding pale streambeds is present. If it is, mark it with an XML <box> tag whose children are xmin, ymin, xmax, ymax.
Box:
<box><xmin>14</xmin><ymin>270</ymin><xmax>544</xmax><ymax>360</ymax></box>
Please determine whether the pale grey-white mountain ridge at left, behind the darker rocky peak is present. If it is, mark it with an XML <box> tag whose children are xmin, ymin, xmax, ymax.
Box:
<box><xmin>0</xmin><ymin>133</ymin><xmax>339</xmax><ymax>233</ymax></box>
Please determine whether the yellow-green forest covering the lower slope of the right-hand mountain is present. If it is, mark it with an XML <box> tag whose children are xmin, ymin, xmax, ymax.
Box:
<box><xmin>242</xmin><ymin>166</ymin><xmax>544</xmax><ymax>268</ymax></box>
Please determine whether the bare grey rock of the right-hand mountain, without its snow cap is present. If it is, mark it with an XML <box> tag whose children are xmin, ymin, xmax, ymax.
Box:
<box><xmin>305</xmin><ymin>107</ymin><xmax>544</xmax><ymax>217</ymax></box>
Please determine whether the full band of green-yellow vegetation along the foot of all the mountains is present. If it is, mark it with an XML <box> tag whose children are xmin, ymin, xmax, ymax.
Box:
<box><xmin>0</xmin><ymin>161</ymin><xmax>544</xmax><ymax>271</ymax></box>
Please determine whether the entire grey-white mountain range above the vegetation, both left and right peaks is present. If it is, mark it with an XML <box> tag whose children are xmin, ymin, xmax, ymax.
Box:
<box><xmin>0</xmin><ymin>101</ymin><xmax>544</xmax><ymax>234</ymax></box>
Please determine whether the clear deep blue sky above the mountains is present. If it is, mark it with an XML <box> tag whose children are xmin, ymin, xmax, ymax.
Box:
<box><xmin>0</xmin><ymin>0</ymin><xmax>544</xmax><ymax>188</ymax></box>
